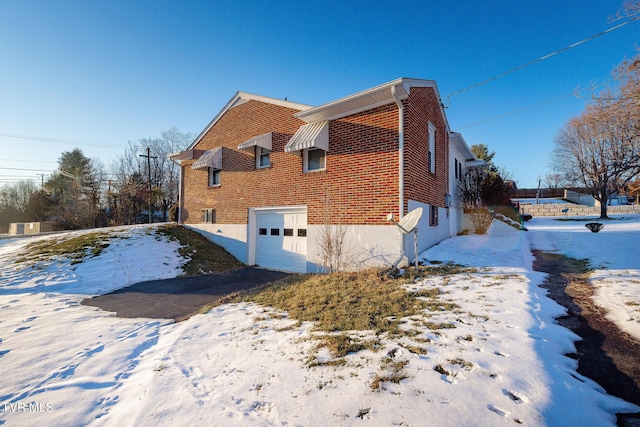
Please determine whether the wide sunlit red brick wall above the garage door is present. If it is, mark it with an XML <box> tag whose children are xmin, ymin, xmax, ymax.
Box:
<box><xmin>182</xmin><ymin>100</ymin><xmax>398</xmax><ymax>224</ymax></box>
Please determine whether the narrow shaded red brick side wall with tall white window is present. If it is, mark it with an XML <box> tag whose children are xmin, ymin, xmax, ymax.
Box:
<box><xmin>404</xmin><ymin>87</ymin><xmax>449</xmax><ymax>212</ymax></box>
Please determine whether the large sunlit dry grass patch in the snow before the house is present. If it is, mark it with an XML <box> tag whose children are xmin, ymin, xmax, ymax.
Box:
<box><xmin>232</xmin><ymin>265</ymin><xmax>473</xmax><ymax>376</ymax></box>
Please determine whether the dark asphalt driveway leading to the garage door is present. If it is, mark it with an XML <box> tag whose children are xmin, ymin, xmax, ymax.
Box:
<box><xmin>82</xmin><ymin>267</ymin><xmax>290</xmax><ymax>321</ymax></box>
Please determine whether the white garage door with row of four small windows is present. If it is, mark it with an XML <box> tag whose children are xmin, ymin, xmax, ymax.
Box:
<box><xmin>256</xmin><ymin>208</ymin><xmax>307</xmax><ymax>273</ymax></box>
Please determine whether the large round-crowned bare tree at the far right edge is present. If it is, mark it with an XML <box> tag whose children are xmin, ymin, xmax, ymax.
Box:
<box><xmin>552</xmin><ymin>57</ymin><xmax>640</xmax><ymax>219</ymax></box>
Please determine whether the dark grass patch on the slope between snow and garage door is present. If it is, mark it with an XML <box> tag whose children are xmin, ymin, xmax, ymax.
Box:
<box><xmin>157</xmin><ymin>224</ymin><xmax>245</xmax><ymax>276</ymax></box>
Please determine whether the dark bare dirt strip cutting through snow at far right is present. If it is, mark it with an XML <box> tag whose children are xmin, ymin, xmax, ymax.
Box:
<box><xmin>533</xmin><ymin>250</ymin><xmax>640</xmax><ymax>426</ymax></box>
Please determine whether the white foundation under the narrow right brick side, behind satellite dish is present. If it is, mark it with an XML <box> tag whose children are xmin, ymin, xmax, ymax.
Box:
<box><xmin>403</xmin><ymin>200</ymin><xmax>451</xmax><ymax>263</ymax></box>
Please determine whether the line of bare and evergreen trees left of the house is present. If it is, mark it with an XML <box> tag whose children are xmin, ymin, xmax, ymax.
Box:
<box><xmin>0</xmin><ymin>128</ymin><xmax>193</xmax><ymax>232</ymax></box>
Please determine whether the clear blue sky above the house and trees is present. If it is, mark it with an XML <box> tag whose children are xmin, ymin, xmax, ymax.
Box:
<box><xmin>0</xmin><ymin>0</ymin><xmax>640</xmax><ymax>188</ymax></box>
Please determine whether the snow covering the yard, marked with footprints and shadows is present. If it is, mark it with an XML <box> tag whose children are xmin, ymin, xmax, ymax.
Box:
<box><xmin>0</xmin><ymin>218</ymin><xmax>640</xmax><ymax>426</ymax></box>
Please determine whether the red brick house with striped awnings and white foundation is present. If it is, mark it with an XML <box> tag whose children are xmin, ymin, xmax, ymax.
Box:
<box><xmin>170</xmin><ymin>78</ymin><xmax>473</xmax><ymax>272</ymax></box>
